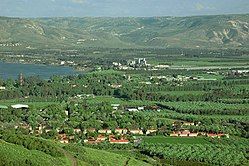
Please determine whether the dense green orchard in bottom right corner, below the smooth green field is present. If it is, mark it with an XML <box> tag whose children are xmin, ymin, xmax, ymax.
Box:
<box><xmin>139</xmin><ymin>143</ymin><xmax>248</xmax><ymax>166</ymax></box>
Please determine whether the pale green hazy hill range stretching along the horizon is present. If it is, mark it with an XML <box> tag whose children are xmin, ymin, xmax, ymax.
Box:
<box><xmin>0</xmin><ymin>14</ymin><xmax>249</xmax><ymax>49</ymax></box>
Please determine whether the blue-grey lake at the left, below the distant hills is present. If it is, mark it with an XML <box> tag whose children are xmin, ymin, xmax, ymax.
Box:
<box><xmin>0</xmin><ymin>61</ymin><xmax>82</xmax><ymax>79</ymax></box>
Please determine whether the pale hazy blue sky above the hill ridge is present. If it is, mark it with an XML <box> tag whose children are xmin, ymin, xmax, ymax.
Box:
<box><xmin>0</xmin><ymin>0</ymin><xmax>249</xmax><ymax>17</ymax></box>
